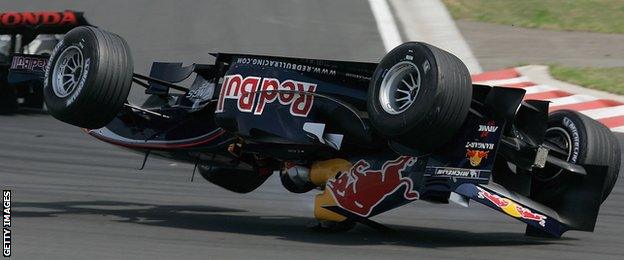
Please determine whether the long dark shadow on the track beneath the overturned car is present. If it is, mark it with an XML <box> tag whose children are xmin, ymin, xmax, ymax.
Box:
<box><xmin>13</xmin><ymin>201</ymin><xmax>574</xmax><ymax>248</ymax></box>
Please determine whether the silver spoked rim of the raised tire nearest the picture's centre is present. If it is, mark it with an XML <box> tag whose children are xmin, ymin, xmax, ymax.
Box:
<box><xmin>379</xmin><ymin>61</ymin><xmax>420</xmax><ymax>115</ymax></box>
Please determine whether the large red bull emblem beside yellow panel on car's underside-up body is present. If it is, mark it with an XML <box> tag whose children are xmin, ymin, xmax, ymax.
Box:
<box><xmin>327</xmin><ymin>156</ymin><xmax>419</xmax><ymax>217</ymax></box>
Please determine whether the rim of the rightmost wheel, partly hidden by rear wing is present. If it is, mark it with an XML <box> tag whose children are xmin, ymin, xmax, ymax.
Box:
<box><xmin>535</xmin><ymin>127</ymin><xmax>572</xmax><ymax>181</ymax></box>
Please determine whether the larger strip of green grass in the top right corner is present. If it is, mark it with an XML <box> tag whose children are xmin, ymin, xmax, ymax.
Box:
<box><xmin>442</xmin><ymin>0</ymin><xmax>624</xmax><ymax>33</ymax></box>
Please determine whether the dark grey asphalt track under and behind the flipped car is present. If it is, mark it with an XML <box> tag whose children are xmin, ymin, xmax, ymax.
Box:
<box><xmin>0</xmin><ymin>0</ymin><xmax>624</xmax><ymax>259</ymax></box>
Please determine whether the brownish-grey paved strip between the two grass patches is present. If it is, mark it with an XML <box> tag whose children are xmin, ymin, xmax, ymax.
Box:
<box><xmin>456</xmin><ymin>20</ymin><xmax>624</xmax><ymax>70</ymax></box>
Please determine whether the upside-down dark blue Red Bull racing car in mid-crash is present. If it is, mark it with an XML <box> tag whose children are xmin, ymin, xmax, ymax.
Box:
<box><xmin>11</xmin><ymin>27</ymin><xmax>620</xmax><ymax>237</ymax></box>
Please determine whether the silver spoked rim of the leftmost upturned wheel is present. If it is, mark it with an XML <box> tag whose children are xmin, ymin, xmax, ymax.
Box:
<box><xmin>52</xmin><ymin>46</ymin><xmax>84</xmax><ymax>98</ymax></box>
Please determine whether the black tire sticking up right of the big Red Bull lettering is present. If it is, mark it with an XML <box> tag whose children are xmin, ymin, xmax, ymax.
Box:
<box><xmin>368</xmin><ymin>42</ymin><xmax>472</xmax><ymax>152</ymax></box>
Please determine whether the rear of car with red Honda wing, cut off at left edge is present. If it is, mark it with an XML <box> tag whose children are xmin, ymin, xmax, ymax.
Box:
<box><xmin>0</xmin><ymin>10</ymin><xmax>89</xmax><ymax>114</ymax></box>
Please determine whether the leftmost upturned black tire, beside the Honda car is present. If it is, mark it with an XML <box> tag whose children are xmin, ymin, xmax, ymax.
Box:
<box><xmin>43</xmin><ymin>26</ymin><xmax>133</xmax><ymax>129</ymax></box>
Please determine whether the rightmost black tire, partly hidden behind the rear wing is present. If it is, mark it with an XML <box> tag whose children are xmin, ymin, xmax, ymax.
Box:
<box><xmin>534</xmin><ymin>110</ymin><xmax>621</xmax><ymax>201</ymax></box>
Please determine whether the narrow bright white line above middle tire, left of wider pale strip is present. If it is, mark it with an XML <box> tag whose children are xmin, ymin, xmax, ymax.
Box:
<box><xmin>368</xmin><ymin>0</ymin><xmax>403</xmax><ymax>52</ymax></box>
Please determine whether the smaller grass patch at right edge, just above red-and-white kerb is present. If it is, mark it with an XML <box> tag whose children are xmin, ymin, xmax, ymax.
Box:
<box><xmin>550</xmin><ymin>65</ymin><xmax>624</xmax><ymax>95</ymax></box>
